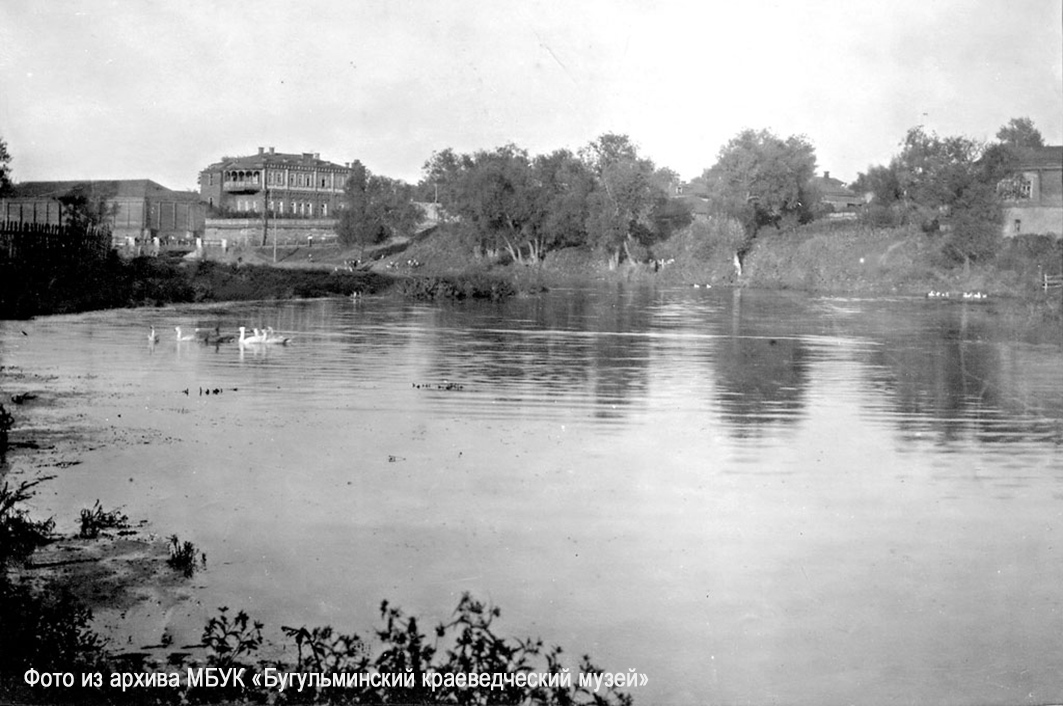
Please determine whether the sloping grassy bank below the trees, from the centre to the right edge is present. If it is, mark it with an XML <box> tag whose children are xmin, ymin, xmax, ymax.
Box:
<box><xmin>404</xmin><ymin>217</ymin><xmax>1063</xmax><ymax>309</ymax></box>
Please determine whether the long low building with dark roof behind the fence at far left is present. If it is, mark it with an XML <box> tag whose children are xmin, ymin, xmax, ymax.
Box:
<box><xmin>0</xmin><ymin>179</ymin><xmax>206</xmax><ymax>245</ymax></box>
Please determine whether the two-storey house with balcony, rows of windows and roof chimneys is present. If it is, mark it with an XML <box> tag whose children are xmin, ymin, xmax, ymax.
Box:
<box><xmin>199</xmin><ymin>147</ymin><xmax>351</xmax><ymax>219</ymax></box>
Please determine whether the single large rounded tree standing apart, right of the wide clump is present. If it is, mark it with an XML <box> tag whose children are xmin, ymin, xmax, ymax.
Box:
<box><xmin>703</xmin><ymin>130</ymin><xmax>815</xmax><ymax>244</ymax></box>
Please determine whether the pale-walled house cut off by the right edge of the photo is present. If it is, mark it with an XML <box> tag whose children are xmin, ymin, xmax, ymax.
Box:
<box><xmin>1003</xmin><ymin>145</ymin><xmax>1063</xmax><ymax>237</ymax></box>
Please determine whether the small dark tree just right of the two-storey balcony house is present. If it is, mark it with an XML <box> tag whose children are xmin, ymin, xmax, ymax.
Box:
<box><xmin>337</xmin><ymin>162</ymin><xmax>423</xmax><ymax>254</ymax></box>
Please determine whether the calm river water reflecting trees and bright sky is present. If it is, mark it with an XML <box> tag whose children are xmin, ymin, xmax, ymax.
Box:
<box><xmin>0</xmin><ymin>287</ymin><xmax>1063</xmax><ymax>705</ymax></box>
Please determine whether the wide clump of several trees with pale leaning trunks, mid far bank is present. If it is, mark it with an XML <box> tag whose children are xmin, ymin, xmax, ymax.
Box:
<box><xmin>419</xmin><ymin>135</ymin><xmax>689</xmax><ymax>265</ymax></box>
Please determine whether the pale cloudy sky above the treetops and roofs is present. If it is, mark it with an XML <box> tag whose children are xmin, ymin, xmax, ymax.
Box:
<box><xmin>0</xmin><ymin>0</ymin><xmax>1063</xmax><ymax>189</ymax></box>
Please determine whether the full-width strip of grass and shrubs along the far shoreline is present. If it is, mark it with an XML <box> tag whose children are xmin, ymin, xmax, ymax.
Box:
<box><xmin>0</xmin><ymin>216</ymin><xmax>1063</xmax><ymax>319</ymax></box>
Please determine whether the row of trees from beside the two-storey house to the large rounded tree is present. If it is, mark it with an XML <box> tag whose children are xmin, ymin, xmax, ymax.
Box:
<box><xmin>340</xmin><ymin>130</ymin><xmax>816</xmax><ymax>268</ymax></box>
